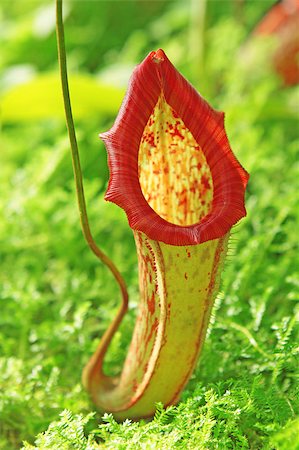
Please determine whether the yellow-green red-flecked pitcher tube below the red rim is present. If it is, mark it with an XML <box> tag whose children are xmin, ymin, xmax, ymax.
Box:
<box><xmin>102</xmin><ymin>231</ymin><xmax>228</xmax><ymax>419</ymax></box>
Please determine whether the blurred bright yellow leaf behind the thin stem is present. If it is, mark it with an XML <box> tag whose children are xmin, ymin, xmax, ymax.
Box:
<box><xmin>0</xmin><ymin>73</ymin><xmax>123</xmax><ymax>123</ymax></box>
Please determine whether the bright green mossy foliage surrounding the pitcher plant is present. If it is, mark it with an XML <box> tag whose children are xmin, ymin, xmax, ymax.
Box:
<box><xmin>0</xmin><ymin>0</ymin><xmax>299</xmax><ymax>450</ymax></box>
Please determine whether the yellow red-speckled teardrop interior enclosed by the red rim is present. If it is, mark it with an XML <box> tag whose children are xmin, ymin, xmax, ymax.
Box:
<box><xmin>138</xmin><ymin>95</ymin><xmax>213</xmax><ymax>226</ymax></box>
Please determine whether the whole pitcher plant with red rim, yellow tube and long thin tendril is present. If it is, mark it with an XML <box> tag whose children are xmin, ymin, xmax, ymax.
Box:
<box><xmin>57</xmin><ymin>0</ymin><xmax>248</xmax><ymax>420</ymax></box>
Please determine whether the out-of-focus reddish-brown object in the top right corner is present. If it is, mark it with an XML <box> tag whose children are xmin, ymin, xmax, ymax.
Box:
<box><xmin>254</xmin><ymin>0</ymin><xmax>299</xmax><ymax>86</ymax></box>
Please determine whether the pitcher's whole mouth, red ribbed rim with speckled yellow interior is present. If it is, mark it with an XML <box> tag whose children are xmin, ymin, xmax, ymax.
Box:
<box><xmin>101</xmin><ymin>50</ymin><xmax>249</xmax><ymax>245</ymax></box>
